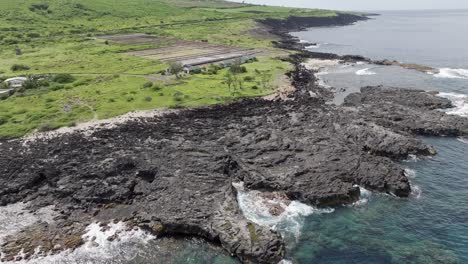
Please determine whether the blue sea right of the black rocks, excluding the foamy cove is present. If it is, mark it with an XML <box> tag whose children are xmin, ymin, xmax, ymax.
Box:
<box><xmin>291</xmin><ymin>11</ymin><xmax>468</xmax><ymax>264</ymax></box>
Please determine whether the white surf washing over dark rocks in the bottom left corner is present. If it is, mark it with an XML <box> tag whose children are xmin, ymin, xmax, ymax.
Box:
<box><xmin>0</xmin><ymin>203</ymin><xmax>156</xmax><ymax>264</ymax></box>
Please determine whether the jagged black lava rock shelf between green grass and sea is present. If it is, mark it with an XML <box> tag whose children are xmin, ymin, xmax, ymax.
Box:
<box><xmin>0</xmin><ymin>13</ymin><xmax>468</xmax><ymax>263</ymax></box>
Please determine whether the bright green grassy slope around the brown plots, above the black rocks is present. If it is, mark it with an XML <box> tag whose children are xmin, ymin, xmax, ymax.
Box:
<box><xmin>0</xmin><ymin>0</ymin><xmax>335</xmax><ymax>138</ymax></box>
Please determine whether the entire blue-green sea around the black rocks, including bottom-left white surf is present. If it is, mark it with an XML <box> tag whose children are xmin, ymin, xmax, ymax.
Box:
<box><xmin>0</xmin><ymin>8</ymin><xmax>468</xmax><ymax>264</ymax></box>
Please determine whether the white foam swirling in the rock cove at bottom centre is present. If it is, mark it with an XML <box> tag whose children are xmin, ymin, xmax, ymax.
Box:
<box><xmin>234</xmin><ymin>184</ymin><xmax>334</xmax><ymax>240</ymax></box>
